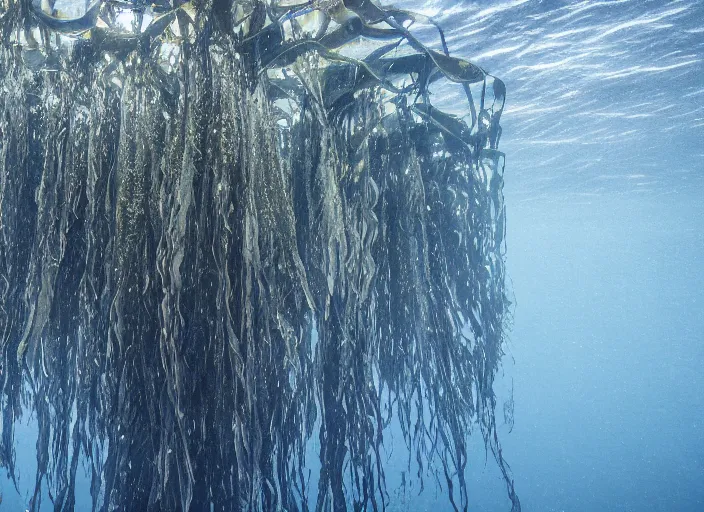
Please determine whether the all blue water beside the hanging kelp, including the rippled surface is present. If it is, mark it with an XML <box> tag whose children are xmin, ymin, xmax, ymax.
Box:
<box><xmin>3</xmin><ymin>0</ymin><xmax>704</xmax><ymax>512</ymax></box>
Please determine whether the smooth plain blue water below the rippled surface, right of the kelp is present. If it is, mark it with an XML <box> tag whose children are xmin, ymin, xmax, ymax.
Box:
<box><xmin>498</xmin><ymin>194</ymin><xmax>704</xmax><ymax>512</ymax></box>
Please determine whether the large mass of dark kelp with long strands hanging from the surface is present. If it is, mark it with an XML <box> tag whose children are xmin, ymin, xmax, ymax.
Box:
<box><xmin>0</xmin><ymin>0</ymin><xmax>520</xmax><ymax>511</ymax></box>
